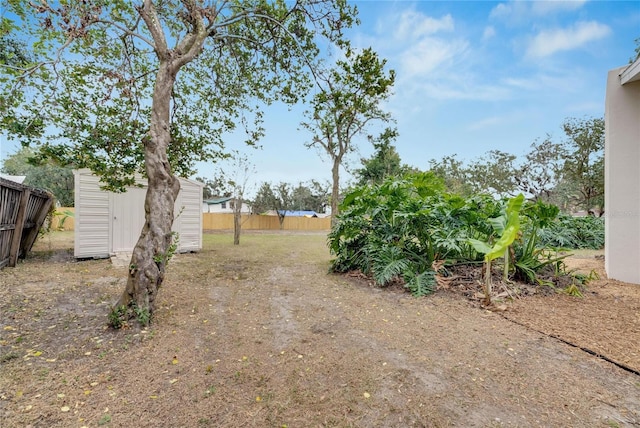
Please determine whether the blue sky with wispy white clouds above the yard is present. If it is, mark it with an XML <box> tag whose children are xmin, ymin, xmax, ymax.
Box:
<box><xmin>0</xmin><ymin>0</ymin><xmax>640</xmax><ymax>194</ymax></box>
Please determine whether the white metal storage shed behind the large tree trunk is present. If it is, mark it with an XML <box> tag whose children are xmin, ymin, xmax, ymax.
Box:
<box><xmin>74</xmin><ymin>169</ymin><xmax>203</xmax><ymax>258</ymax></box>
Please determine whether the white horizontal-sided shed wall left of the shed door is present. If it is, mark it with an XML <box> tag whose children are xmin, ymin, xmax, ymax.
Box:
<box><xmin>73</xmin><ymin>170</ymin><xmax>111</xmax><ymax>258</ymax></box>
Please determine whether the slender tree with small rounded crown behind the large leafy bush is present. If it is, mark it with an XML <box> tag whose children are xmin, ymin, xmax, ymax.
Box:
<box><xmin>301</xmin><ymin>48</ymin><xmax>395</xmax><ymax>219</ymax></box>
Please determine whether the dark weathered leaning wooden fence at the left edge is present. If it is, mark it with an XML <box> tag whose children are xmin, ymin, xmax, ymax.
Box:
<box><xmin>0</xmin><ymin>178</ymin><xmax>53</xmax><ymax>269</ymax></box>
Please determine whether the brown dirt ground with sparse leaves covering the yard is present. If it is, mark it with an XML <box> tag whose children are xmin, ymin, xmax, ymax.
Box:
<box><xmin>0</xmin><ymin>232</ymin><xmax>640</xmax><ymax>428</ymax></box>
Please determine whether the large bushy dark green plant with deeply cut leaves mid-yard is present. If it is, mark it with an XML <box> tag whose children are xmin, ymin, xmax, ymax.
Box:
<box><xmin>328</xmin><ymin>173</ymin><xmax>499</xmax><ymax>296</ymax></box>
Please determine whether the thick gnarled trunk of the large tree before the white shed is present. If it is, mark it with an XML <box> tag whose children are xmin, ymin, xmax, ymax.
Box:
<box><xmin>116</xmin><ymin>63</ymin><xmax>180</xmax><ymax>325</ymax></box>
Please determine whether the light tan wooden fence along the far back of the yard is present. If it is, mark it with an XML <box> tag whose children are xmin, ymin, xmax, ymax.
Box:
<box><xmin>51</xmin><ymin>207</ymin><xmax>331</xmax><ymax>230</ymax></box>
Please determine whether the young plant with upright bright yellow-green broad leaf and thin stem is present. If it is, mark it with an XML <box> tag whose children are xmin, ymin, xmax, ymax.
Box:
<box><xmin>469</xmin><ymin>193</ymin><xmax>524</xmax><ymax>305</ymax></box>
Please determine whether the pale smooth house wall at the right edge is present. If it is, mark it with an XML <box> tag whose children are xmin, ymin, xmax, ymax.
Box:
<box><xmin>604</xmin><ymin>57</ymin><xmax>640</xmax><ymax>284</ymax></box>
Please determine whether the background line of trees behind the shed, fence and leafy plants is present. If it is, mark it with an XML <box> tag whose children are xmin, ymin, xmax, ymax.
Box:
<box><xmin>1</xmin><ymin>114</ymin><xmax>604</xmax><ymax>215</ymax></box>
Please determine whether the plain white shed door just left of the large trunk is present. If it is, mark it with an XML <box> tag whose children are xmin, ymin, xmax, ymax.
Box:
<box><xmin>112</xmin><ymin>187</ymin><xmax>147</xmax><ymax>253</ymax></box>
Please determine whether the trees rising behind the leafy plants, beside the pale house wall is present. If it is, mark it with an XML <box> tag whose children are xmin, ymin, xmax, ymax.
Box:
<box><xmin>429</xmin><ymin>118</ymin><xmax>604</xmax><ymax>213</ymax></box>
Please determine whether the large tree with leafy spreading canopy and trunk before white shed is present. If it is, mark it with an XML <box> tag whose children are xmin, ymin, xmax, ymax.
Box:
<box><xmin>0</xmin><ymin>0</ymin><xmax>355</xmax><ymax>326</ymax></box>
